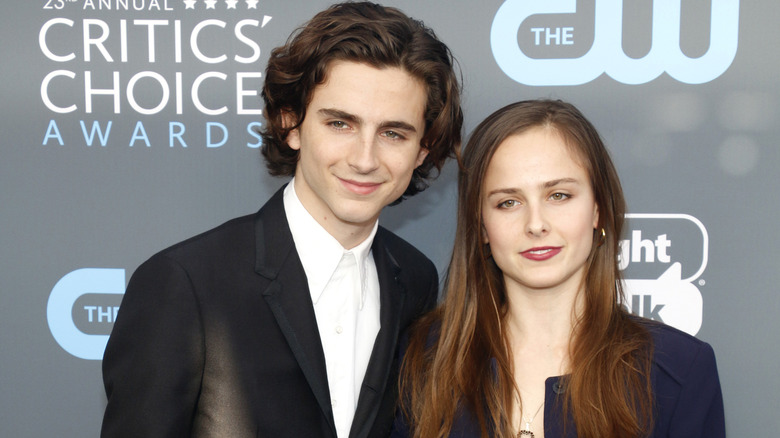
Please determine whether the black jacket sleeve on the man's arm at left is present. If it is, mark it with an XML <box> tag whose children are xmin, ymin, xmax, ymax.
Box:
<box><xmin>101</xmin><ymin>255</ymin><xmax>204</xmax><ymax>438</ymax></box>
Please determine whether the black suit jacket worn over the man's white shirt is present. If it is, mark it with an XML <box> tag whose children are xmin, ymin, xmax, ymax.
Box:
<box><xmin>101</xmin><ymin>186</ymin><xmax>438</xmax><ymax>438</ymax></box>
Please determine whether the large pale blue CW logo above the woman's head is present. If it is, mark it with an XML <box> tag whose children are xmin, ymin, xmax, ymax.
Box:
<box><xmin>490</xmin><ymin>0</ymin><xmax>739</xmax><ymax>86</ymax></box>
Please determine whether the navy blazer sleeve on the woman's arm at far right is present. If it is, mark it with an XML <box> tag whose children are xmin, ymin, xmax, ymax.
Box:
<box><xmin>669</xmin><ymin>343</ymin><xmax>726</xmax><ymax>438</ymax></box>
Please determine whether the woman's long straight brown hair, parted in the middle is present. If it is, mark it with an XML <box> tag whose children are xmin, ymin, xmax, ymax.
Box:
<box><xmin>401</xmin><ymin>100</ymin><xmax>653</xmax><ymax>438</ymax></box>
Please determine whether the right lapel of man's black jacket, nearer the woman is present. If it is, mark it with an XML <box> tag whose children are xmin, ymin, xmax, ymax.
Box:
<box><xmin>349</xmin><ymin>229</ymin><xmax>406</xmax><ymax>438</ymax></box>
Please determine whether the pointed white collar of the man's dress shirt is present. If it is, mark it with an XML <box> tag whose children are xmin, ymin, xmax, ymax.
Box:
<box><xmin>283</xmin><ymin>177</ymin><xmax>379</xmax><ymax>308</ymax></box>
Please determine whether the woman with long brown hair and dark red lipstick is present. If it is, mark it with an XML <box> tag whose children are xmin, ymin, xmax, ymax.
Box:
<box><xmin>394</xmin><ymin>100</ymin><xmax>725</xmax><ymax>438</ymax></box>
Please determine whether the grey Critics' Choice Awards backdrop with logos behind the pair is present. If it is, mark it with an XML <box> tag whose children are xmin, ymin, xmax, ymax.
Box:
<box><xmin>0</xmin><ymin>0</ymin><xmax>780</xmax><ymax>437</ymax></box>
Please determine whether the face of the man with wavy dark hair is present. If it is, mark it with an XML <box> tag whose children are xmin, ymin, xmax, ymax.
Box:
<box><xmin>287</xmin><ymin>61</ymin><xmax>428</xmax><ymax>248</ymax></box>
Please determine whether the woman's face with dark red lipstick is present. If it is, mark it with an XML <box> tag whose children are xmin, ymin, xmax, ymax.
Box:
<box><xmin>482</xmin><ymin>127</ymin><xmax>599</xmax><ymax>293</ymax></box>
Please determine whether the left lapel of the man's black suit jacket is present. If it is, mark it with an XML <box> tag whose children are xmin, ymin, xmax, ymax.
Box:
<box><xmin>255</xmin><ymin>188</ymin><xmax>336</xmax><ymax>437</ymax></box>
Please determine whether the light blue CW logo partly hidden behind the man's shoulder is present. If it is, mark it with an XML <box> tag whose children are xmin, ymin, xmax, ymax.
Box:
<box><xmin>46</xmin><ymin>268</ymin><xmax>125</xmax><ymax>360</ymax></box>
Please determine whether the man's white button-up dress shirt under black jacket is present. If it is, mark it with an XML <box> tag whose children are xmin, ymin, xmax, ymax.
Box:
<box><xmin>284</xmin><ymin>178</ymin><xmax>380</xmax><ymax>438</ymax></box>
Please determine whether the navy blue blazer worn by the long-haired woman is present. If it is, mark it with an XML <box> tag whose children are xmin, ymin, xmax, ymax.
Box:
<box><xmin>392</xmin><ymin>323</ymin><xmax>726</xmax><ymax>438</ymax></box>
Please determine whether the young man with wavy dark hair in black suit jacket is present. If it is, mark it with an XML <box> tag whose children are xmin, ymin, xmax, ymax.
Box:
<box><xmin>102</xmin><ymin>3</ymin><xmax>462</xmax><ymax>438</ymax></box>
